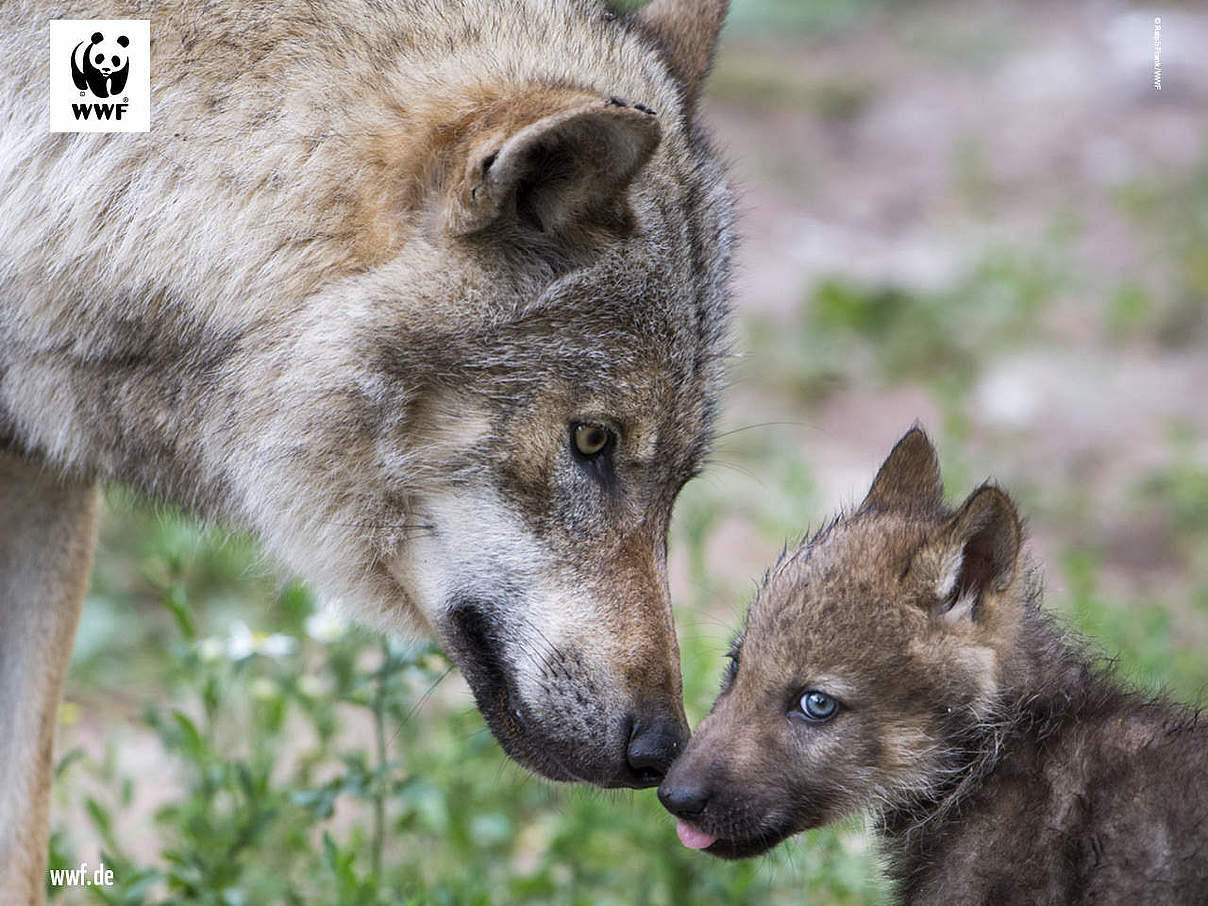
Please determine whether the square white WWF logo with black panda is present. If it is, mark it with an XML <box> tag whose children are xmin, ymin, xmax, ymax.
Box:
<box><xmin>49</xmin><ymin>19</ymin><xmax>151</xmax><ymax>132</ymax></box>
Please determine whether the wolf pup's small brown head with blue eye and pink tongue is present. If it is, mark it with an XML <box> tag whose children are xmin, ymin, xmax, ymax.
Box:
<box><xmin>660</xmin><ymin>429</ymin><xmax>1033</xmax><ymax>859</ymax></box>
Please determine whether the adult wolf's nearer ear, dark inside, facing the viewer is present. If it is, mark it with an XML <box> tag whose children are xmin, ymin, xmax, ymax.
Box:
<box><xmin>445</xmin><ymin>100</ymin><xmax>660</xmax><ymax>239</ymax></box>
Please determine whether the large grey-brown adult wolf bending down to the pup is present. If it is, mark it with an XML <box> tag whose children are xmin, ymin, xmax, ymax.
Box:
<box><xmin>0</xmin><ymin>0</ymin><xmax>731</xmax><ymax>901</ymax></box>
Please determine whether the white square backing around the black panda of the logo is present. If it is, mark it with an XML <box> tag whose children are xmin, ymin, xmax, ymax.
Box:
<box><xmin>50</xmin><ymin>19</ymin><xmax>151</xmax><ymax>132</ymax></box>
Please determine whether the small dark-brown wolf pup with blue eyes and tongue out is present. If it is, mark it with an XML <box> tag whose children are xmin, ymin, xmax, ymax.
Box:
<box><xmin>658</xmin><ymin>429</ymin><xmax>1208</xmax><ymax>906</ymax></box>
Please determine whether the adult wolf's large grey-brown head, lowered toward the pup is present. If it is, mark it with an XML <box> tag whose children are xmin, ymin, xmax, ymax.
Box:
<box><xmin>210</xmin><ymin>0</ymin><xmax>731</xmax><ymax>786</ymax></box>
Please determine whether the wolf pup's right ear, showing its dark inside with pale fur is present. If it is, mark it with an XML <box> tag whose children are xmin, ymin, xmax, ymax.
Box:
<box><xmin>936</xmin><ymin>484</ymin><xmax>1023</xmax><ymax>620</ymax></box>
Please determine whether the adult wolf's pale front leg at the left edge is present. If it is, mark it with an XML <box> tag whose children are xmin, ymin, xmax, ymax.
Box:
<box><xmin>0</xmin><ymin>452</ymin><xmax>97</xmax><ymax>906</ymax></box>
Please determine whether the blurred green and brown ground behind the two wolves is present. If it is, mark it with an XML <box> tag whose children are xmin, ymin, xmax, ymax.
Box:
<box><xmin>52</xmin><ymin>0</ymin><xmax>1208</xmax><ymax>906</ymax></box>
